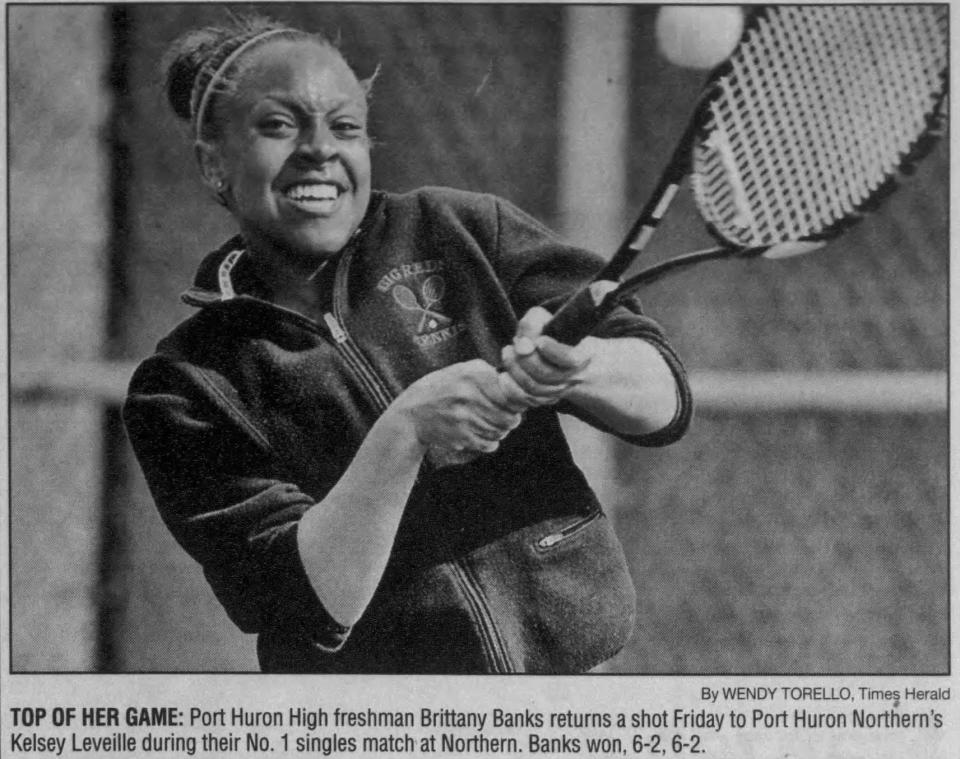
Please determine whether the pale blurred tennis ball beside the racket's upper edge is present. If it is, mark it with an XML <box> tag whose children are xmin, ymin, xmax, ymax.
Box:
<box><xmin>656</xmin><ymin>5</ymin><xmax>743</xmax><ymax>69</ymax></box>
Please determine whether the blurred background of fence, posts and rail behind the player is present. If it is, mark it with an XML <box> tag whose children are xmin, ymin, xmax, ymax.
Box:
<box><xmin>7</xmin><ymin>3</ymin><xmax>948</xmax><ymax>674</ymax></box>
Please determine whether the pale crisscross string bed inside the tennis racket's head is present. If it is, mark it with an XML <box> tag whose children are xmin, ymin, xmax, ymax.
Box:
<box><xmin>693</xmin><ymin>6</ymin><xmax>948</xmax><ymax>247</ymax></box>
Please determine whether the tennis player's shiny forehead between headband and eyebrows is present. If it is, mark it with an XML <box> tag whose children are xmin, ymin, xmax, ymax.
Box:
<box><xmin>235</xmin><ymin>40</ymin><xmax>366</xmax><ymax>110</ymax></box>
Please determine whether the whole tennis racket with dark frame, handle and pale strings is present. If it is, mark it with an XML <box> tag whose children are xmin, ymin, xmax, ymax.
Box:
<box><xmin>544</xmin><ymin>5</ymin><xmax>949</xmax><ymax>345</ymax></box>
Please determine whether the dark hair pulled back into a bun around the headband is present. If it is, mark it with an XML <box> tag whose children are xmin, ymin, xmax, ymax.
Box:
<box><xmin>163</xmin><ymin>16</ymin><xmax>334</xmax><ymax>139</ymax></box>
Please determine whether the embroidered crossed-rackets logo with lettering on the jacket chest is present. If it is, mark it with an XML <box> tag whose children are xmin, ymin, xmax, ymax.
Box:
<box><xmin>377</xmin><ymin>259</ymin><xmax>465</xmax><ymax>348</ymax></box>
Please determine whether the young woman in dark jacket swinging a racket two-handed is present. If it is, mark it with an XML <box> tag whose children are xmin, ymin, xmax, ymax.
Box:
<box><xmin>124</xmin><ymin>16</ymin><xmax>690</xmax><ymax>672</ymax></box>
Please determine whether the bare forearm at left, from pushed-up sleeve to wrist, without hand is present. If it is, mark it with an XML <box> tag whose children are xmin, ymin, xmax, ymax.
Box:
<box><xmin>297</xmin><ymin>411</ymin><xmax>424</xmax><ymax>625</ymax></box>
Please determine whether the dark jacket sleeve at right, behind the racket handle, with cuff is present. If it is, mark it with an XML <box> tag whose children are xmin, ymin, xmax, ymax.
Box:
<box><xmin>495</xmin><ymin>193</ymin><xmax>693</xmax><ymax>446</ymax></box>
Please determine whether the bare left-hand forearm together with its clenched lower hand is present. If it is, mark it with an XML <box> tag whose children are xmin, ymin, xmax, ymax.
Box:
<box><xmin>297</xmin><ymin>359</ymin><xmax>520</xmax><ymax>625</ymax></box>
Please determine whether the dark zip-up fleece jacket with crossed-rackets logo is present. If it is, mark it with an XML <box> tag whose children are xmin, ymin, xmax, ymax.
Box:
<box><xmin>124</xmin><ymin>188</ymin><xmax>690</xmax><ymax>672</ymax></box>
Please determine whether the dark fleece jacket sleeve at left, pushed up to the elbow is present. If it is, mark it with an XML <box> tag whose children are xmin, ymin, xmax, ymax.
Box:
<box><xmin>123</xmin><ymin>356</ymin><xmax>349</xmax><ymax>651</ymax></box>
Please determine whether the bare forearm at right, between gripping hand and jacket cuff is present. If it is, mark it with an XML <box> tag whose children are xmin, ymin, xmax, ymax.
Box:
<box><xmin>566</xmin><ymin>337</ymin><xmax>678</xmax><ymax>435</ymax></box>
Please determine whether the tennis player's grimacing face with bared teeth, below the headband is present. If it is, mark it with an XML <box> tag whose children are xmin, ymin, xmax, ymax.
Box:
<box><xmin>206</xmin><ymin>40</ymin><xmax>370</xmax><ymax>267</ymax></box>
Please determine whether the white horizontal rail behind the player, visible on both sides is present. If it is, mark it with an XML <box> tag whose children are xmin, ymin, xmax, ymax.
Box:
<box><xmin>10</xmin><ymin>360</ymin><xmax>948</xmax><ymax>414</ymax></box>
